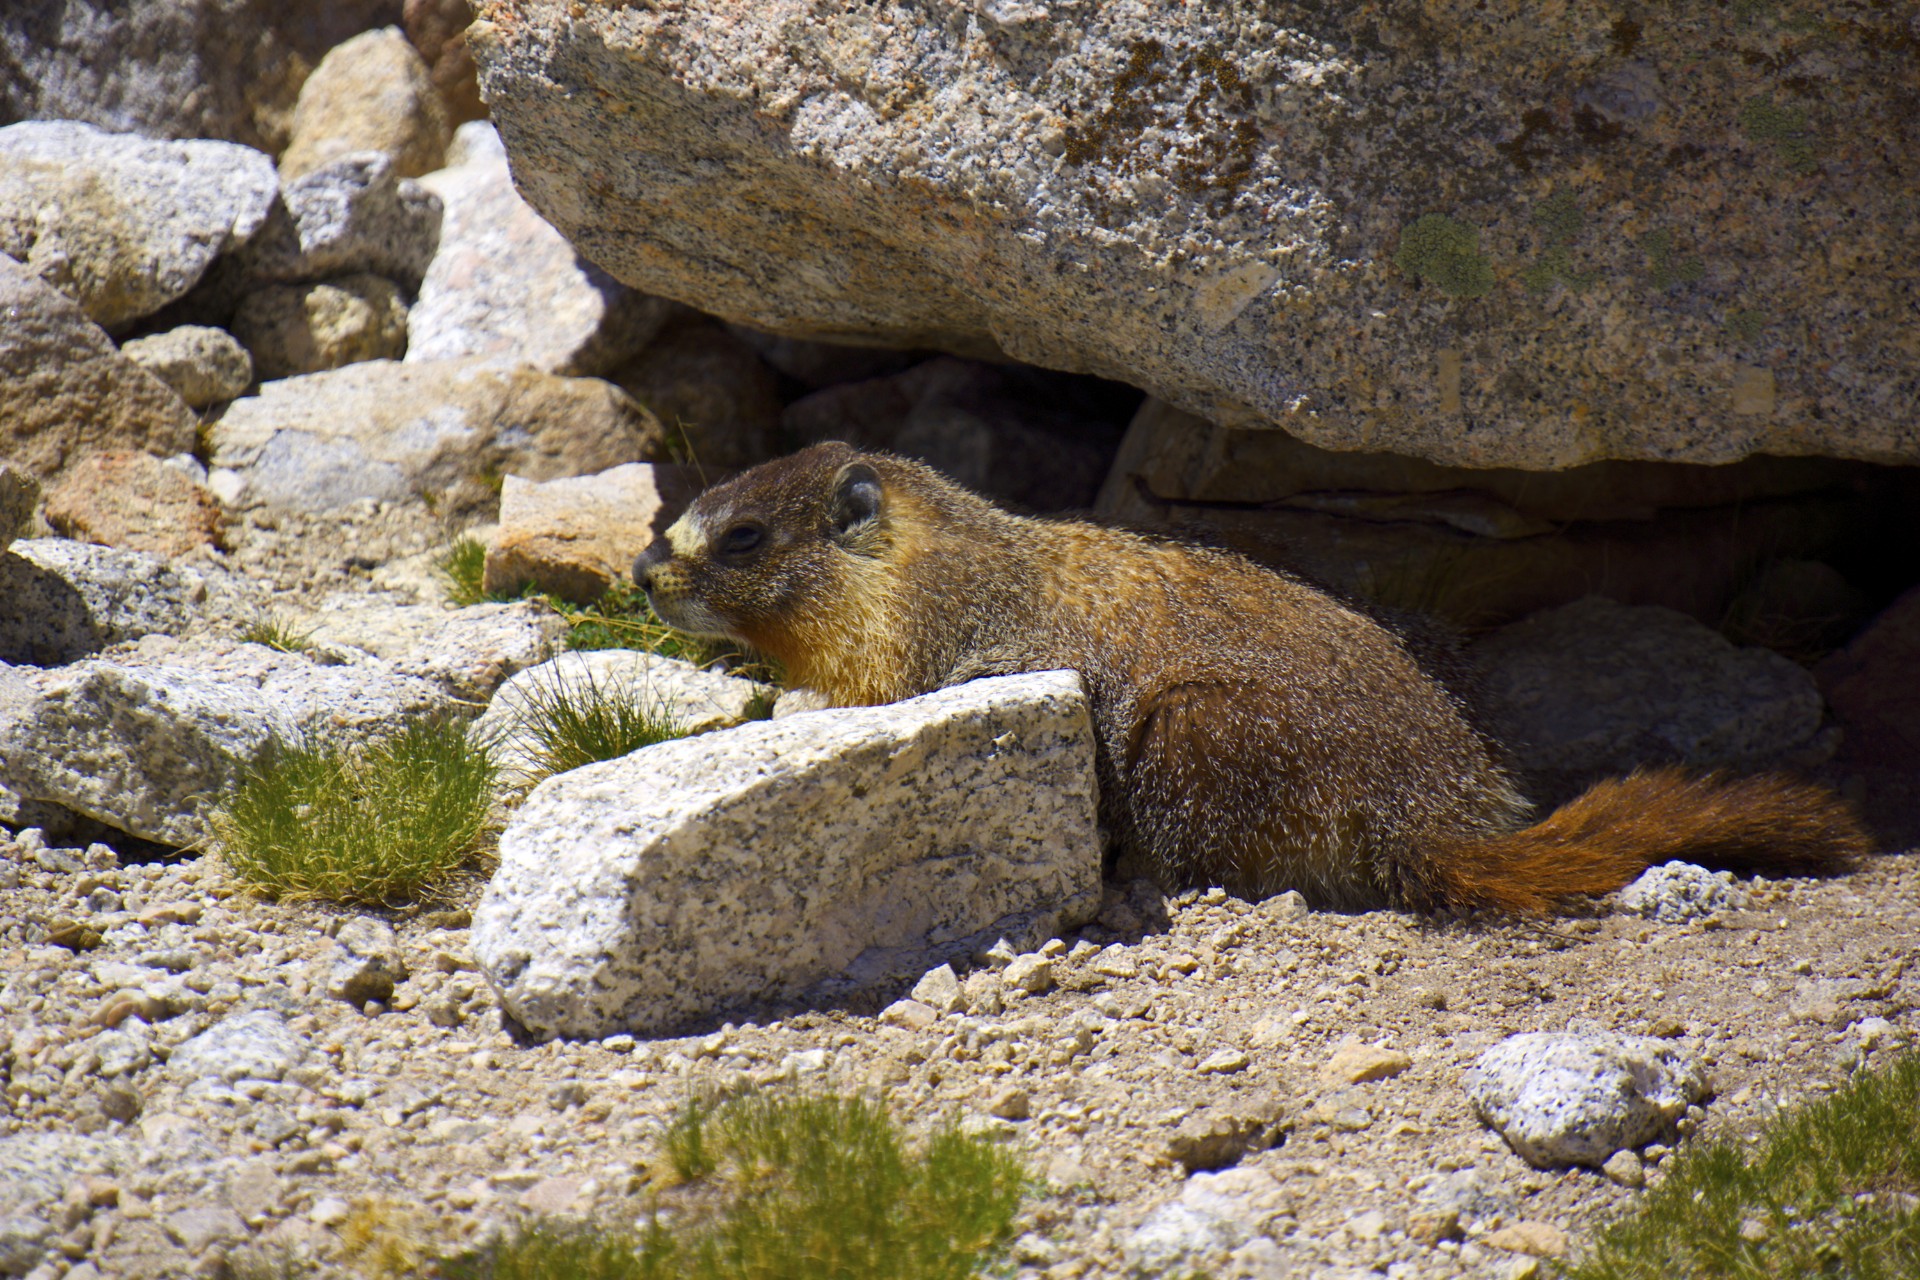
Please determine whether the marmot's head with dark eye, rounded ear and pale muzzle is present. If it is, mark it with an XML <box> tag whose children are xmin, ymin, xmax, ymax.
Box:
<box><xmin>634</xmin><ymin>441</ymin><xmax>891</xmax><ymax>664</ymax></box>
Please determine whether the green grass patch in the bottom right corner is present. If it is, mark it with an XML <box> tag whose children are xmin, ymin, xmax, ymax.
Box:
<box><xmin>1565</xmin><ymin>1052</ymin><xmax>1920</xmax><ymax>1280</ymax></box>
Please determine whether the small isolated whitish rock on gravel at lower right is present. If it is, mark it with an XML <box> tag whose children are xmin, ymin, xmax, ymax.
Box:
<box><xmin>1461</xmin><ymin>1031</ymin><xmax>1709</xmax><ymax>1169</ymax></box>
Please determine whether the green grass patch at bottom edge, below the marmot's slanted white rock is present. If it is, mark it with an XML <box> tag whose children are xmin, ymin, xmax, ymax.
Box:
<box><xmin>447</xmin><ymin>1096</ymin><xmax>1027</xmax><ymax>1280</ymax></box>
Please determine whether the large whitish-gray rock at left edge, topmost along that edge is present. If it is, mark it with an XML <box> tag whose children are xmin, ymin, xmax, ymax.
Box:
<box><xmin>0</xmin><ymin>121</ymin><xmax>278</xmax><ymax>328</ymax></box>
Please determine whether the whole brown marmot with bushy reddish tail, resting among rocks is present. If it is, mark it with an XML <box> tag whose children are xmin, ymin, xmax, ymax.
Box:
<box><xmin>634</xmin><ymin>443</ymin><xmax>1866</xmax><ymax>912</ymax></box>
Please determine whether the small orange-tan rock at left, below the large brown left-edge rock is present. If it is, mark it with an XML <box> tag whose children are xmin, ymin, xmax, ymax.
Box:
<box><xmin>41</xmin><ymin>451</ymin><xmax>225</xmax><ymax>556</ymax></box>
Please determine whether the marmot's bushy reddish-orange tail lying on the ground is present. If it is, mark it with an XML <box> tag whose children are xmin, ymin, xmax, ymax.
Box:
<box><xmin>1432</xmin><ymin>770</ymin><xmax>1872</xmax><ymax>913</ymax></box>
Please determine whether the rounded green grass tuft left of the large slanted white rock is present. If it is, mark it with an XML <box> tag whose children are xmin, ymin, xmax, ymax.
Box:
<box><xmin>211</xmin><ymin>722</ymin><xmax>495</xmax><ymax>904</ymax></box>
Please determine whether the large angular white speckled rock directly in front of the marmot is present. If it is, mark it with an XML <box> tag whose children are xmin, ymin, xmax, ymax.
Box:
<box><xmin>472</xmin><ymin>672</ymin><xmax>1100</xmax><ymax>1038</ymax></box>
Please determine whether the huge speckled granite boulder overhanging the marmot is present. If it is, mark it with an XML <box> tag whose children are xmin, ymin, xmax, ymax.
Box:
<box><xmin>468</xmin><ymin>0</ymin><xmax>1920</xmax><ymax>468</ymax></box>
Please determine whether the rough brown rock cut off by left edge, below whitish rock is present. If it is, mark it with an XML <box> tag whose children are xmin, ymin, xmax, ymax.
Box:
<box><xmin>0</xmin><ymin>253</ymin><xmax>198</xmax><ymax>480</ymax></box>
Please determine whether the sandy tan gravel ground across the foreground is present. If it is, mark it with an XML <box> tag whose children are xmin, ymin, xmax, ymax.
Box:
<box><xmin>0</xmin><ymin>839</ymin><xmax>1920</xmax><ymax>1280</ymax></box>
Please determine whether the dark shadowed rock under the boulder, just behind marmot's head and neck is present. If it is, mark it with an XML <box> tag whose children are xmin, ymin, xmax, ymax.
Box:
<box><xmin>781</xmin><ymin>357</ymin><xmax>1133</xmax><ymax>510</ymax></box>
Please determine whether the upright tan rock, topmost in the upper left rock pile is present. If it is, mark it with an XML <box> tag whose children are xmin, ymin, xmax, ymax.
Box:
<box><xmin>280</xmin><ymin>27</ymin><xmax>449</xmax><ymax>178</ymax></box>
